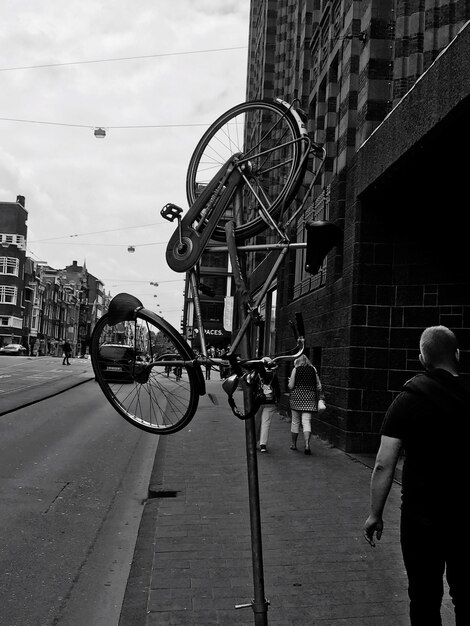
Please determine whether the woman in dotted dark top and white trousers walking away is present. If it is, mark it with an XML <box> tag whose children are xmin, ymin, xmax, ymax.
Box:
<box><xmin>288</xmin><ymin>354</ymin><xmax>325</xmax><ymax>455</ymax></box>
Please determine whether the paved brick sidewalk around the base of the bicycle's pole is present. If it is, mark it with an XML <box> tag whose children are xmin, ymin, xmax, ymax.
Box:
<box><xmin>119</xmin><ymin>380</ymin><xmax>454</xmax><ymax>626</ymax></box>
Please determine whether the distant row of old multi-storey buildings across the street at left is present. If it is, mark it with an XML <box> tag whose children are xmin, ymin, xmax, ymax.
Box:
<box><xmin>0</xmin><ymin>196</ymin><xmax>107</xmax><ymax>357</ymax></box>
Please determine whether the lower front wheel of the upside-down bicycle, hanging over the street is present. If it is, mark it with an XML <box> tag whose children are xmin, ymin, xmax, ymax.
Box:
<box><xmin>91</xmin><ymin>309</ymin><xmax>204</xmax><ymax>435</ymax></box>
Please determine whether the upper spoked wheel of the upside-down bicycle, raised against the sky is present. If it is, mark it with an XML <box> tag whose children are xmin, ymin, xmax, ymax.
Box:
<box><xmin>186</xmin><ymin>100</ymin><xmax>307</xmax><ymax>241</ymax></box>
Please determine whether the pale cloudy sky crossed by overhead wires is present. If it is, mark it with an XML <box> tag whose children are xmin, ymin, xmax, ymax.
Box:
<box><xmin>0</xmin><ymin>0</ymin><xmax>250</xmax><ymax>329</ymax></box>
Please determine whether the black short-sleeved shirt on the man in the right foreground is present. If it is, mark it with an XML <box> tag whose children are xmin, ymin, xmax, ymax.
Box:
<box><xmin>381</xmin><ymin>369</ymin><xmax>470</xmax><ymax>522</ymax></box>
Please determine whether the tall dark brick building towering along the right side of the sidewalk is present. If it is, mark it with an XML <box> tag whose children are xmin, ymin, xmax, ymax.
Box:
<box><xmin>247</xmin><ymin>0</ymin><xmax>470</xmax><ymax>452</ymax></box>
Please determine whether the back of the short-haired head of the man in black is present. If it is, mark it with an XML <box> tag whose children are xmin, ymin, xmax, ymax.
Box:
<box><xmin>419</xmin><ymin>326</ymin><xmax>459</xmax><ymax>374</ymax></box>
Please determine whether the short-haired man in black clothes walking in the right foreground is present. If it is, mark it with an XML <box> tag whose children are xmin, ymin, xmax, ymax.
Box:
<box><xmin>363</xmin><ymin>326</ymin><xmax>470</xmax><ymax>626</ymax></box>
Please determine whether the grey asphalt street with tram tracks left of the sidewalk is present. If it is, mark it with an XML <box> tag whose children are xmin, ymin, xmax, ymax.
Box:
<box><xmin>0</xmin><ymin>357</ymin><xmax>158</xmax><ymax>626</ymax></box>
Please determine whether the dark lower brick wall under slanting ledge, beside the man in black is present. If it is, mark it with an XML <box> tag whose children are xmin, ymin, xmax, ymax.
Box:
<box><xmin>278</xmin><ymin>23</ymin><xmax>470</xmax><ymax>452</ymax></box>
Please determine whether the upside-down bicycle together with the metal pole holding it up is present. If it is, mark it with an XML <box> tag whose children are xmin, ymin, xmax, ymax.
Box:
<box><xmin>91</xmin><ymin>99</ymin><xmax>341</xmax><ymax>626</ymax></box>
